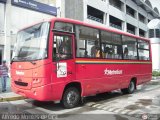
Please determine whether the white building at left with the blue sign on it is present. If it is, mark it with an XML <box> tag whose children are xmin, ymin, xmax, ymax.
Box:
<box><xmin>0</xmin><ymin>0</ymin><xmax>57</xmax><ymax>64</ymax></box>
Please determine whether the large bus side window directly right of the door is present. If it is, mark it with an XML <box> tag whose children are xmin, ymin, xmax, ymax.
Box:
<box><xmin>76</xmin><ymin>25</ymin><xmax>100</xmax><ymax>58</ymax></box>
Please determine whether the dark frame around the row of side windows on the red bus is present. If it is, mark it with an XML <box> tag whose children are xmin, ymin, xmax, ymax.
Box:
<box><xmin>52</xmin><ymin>21</ymin><xmax>151</xmax><ymax>61</ymax></box>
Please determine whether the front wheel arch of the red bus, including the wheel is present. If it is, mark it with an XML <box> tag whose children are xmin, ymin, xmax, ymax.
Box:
<box><xmin>61</xmin><ymin>82</ymin><xmax>82</xmax><ymax>109</ymax></box>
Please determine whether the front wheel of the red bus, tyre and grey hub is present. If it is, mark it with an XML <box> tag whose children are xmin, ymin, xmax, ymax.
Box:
<box><xmin>61</xmin><ymin>87</ymin><xmax>81</xmax><ymax>109</ymax></box>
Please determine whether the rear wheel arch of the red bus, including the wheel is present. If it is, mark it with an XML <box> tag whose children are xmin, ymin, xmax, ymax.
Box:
<box><xmin>121</xmin><ymin>77</ymin><xmax>137</xmax><ymax>94</ymax></box>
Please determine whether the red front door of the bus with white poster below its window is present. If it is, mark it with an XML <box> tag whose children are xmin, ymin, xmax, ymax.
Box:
<box><xmin>52</xmin><ymin>32</ymin><xmax>75</xmax><ymax>93</ymax></box>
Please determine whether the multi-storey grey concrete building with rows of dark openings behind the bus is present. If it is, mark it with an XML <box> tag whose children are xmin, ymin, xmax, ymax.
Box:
<box><xmin>61</xmin><ymin>0</ymin><xmax>159</xmax><ymax>37</ymax></box>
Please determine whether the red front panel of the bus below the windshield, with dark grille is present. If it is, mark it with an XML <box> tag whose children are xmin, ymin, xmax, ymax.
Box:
<box><xmin>11</xmin><ymin>60</ymin><xmax>53</xmax><ymax>100</ymax></box>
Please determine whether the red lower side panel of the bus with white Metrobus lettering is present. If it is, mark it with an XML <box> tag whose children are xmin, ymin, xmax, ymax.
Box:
<box><xmin>76</xmin><ymin>59</ymin><xmax>152</xmax><ymax>96</ymax></box>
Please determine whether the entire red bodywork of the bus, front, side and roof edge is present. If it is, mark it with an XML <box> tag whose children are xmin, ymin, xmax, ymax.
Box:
<box><xmin>11</xmin><ymin>18</ymin><xmax>152</xmax><ymax>101</ymax></box>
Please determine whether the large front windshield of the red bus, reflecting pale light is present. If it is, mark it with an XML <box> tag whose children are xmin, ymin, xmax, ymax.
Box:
<box><xmin>12</xmin><ymin>22</ymin><xmax>50</xmax><ymax>61</ymax></box>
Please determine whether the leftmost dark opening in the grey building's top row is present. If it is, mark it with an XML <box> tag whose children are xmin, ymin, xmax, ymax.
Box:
<box><xmin>109</xmin><ymin>0</ymin><xmax>124</xmax><ymax>11</ymax></box>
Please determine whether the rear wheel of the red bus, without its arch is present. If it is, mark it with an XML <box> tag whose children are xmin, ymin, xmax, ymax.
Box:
<box><xmin>121</xmin><ymin>80</ymin><xmax>135</xmax><ymax>94</ymax></box>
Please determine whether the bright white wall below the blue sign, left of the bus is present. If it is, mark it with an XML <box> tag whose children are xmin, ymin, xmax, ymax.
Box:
<box><xmin>0</xmin><ymin>0</ymin><xmax>57</xmax><ymax>62</ymax></box>
